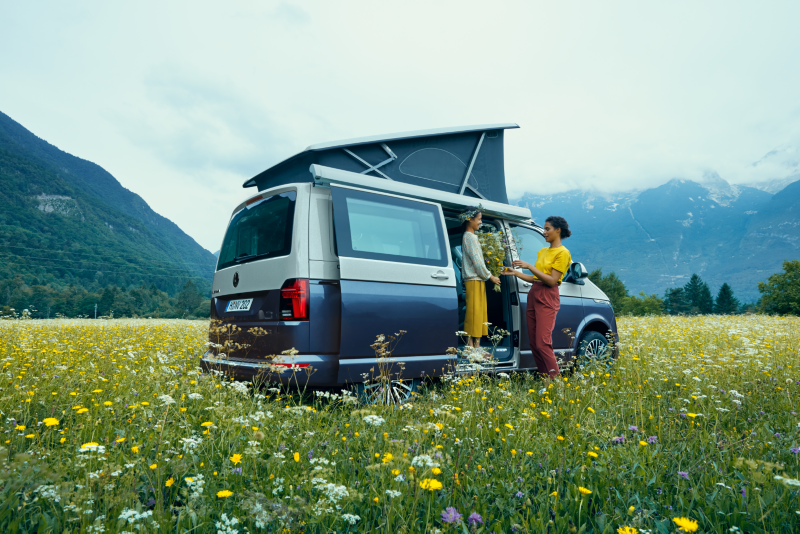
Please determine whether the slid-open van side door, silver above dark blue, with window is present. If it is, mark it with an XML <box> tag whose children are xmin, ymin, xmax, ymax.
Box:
<box><xmin>331</xmin><ymin>185</ymin><xmax>458</xmax><ymax>358</ymax></box>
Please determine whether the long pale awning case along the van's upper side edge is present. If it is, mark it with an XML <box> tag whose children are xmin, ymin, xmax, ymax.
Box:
<box><xmin>309</xmin><ymin>164</ymin><xmax>531</xmax><ymax>222</ymax></box>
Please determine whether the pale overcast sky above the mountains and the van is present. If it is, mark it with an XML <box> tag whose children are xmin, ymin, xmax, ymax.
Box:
<box><xmin>0</xmin><ymin>0</ymin><xmax>800</xmax><ymax>251</ymax></box>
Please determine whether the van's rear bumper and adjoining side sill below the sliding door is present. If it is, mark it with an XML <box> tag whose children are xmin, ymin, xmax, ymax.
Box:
<box><xmin>200</xmin><ymin>352</ymin><xmax>456</xmax><ymax>387</ymax></box>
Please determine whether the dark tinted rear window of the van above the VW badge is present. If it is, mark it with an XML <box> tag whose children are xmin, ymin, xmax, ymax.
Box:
<box><xmin>217</xmin><ymin>191</ymin><xmax>297</xmax><ymax>271</ymax></box>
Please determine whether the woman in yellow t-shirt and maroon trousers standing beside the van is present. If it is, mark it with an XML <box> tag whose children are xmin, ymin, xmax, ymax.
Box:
<box><xmin>503</xmin><ymin>217</ymin><xmax>572</xmax><ymax>378</ymax></box>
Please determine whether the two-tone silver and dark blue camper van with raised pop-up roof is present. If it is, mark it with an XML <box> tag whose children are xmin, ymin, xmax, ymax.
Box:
<box><xmin>202</xmin><ymin>124</ymin><xmax>617</xmax><ymax>401</ymax></box>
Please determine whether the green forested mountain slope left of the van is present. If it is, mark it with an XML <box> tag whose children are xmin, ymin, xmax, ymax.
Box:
<box><xmin>0</xmin><ymin>113</ymin><xmax>216</xmax><ymax>305</ymax></box>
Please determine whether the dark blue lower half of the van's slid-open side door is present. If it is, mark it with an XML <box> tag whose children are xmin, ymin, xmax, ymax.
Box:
<box><xmin>340</xmin><ymin>280</ymin><xmax>458</xmax><ymax>358</ymax></box>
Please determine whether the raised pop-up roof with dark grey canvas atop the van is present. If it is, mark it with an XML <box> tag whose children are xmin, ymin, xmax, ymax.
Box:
<box><xmin>244</xmin><ymin>123</ymin><xmax>519</xmax><ymax>204</ymax></box>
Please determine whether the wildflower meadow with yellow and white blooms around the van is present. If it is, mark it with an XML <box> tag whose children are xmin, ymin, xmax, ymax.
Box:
<box><xmin>0</xmin><ymin>315</ymin><xmax>800</xmax><ymax>533</ymax></box>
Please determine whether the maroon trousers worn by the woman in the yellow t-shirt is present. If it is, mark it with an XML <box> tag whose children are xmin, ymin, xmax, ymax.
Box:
<box><xmin>525</xmin><ymin>282</ymin><xmax>561</xmax><ymax>378</ymax></box>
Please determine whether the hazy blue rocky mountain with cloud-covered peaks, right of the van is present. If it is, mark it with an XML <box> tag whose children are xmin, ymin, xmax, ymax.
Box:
<box><xmin>515</xmin><ymin>173</ymin><xmax>800</xmax><ymax>302</ymax></box>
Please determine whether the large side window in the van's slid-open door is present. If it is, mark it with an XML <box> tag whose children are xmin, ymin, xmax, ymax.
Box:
<box><xmin>331</xmin><ymin>187</ymin><xmax>448</xmax><ymax>267</ymax></box>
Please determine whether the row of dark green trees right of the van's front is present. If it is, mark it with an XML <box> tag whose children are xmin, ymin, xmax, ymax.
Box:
<box><xmin>589</xmin><ymin>260</ymin><xmax>800</xmax><ymax>315</ymax></box>
